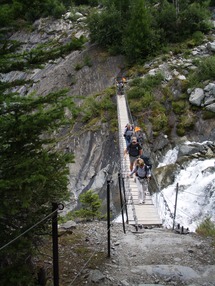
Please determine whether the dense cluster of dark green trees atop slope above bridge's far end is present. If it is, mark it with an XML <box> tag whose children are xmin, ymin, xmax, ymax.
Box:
<box><xmin>89</xmin><ymin>0</ymin><xmax>211</xmax><ymax>63</ymax></box>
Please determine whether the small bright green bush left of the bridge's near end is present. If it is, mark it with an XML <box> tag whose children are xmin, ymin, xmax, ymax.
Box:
<box><xmin>74</xmin><ymin>190</ymin><xmax>102</xmax><ymax>219</ymax></box>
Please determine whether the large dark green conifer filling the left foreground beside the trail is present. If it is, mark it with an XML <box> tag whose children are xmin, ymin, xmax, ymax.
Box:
<box><xmin>0</xmin><ymin>87</ymin><xmax>75</xmax><ymax>286</ymax></box>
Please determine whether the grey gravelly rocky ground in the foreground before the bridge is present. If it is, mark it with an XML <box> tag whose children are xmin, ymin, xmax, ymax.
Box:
<box><xmin>52</xmin><ymin>222</ymin><xmax>215</xmax><ymax>286</ymax></box>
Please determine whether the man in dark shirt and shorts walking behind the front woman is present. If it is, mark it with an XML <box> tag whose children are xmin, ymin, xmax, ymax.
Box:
<box><xmin>124</xmin><ymin>137</ymin><xmax>143</xmax><ymax>172</ymax></box>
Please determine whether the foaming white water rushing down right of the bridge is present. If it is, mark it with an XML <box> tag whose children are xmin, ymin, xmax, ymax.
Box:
<box><xmin>153</xmin><ymin>142</ymin><xmax>215</xmax><ymax>231</ymax></box>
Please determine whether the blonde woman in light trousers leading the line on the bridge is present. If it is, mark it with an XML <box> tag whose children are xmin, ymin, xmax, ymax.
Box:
<box><xmin>129</xmin><ymin>158</ymin><xmax>151</xmax><ymax>204</ymax></box>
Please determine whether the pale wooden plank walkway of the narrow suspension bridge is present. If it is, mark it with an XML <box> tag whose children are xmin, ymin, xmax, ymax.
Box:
<box><xmin>117</xmin><ymin>92</ymin><xmax>162</xmax><ymax>227</ymax></box>
